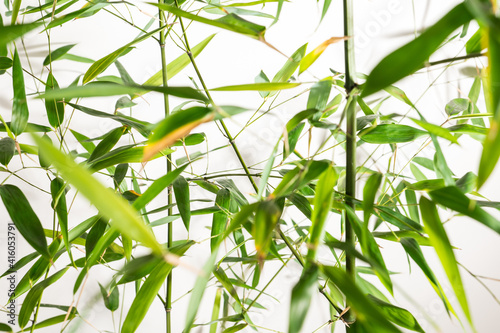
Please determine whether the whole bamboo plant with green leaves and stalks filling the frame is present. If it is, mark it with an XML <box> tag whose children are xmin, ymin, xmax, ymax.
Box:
<box><xmin>0</xmin><ymin>0</ymin><xmax>500</xmax><ymax>333</ymax></box>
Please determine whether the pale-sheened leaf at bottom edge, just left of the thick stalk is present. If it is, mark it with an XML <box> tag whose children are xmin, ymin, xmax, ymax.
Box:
<box><xmin>288</xmin><ymin>265</ymin><xmax>318</xmax><ymax>333</ymax></box>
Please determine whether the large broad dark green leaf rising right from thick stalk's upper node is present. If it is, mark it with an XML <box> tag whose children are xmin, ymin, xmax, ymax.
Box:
<box><xmin>362</xmin><ymin>3</ymin><xmax>472</xmax><ymax>97</ymax></box>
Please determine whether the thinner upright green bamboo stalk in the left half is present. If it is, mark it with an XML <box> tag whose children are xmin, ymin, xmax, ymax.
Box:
<box><xmin>158</xmin><ymin>0</ymin><xmax>173</xmax><ymax>333</ymax></box>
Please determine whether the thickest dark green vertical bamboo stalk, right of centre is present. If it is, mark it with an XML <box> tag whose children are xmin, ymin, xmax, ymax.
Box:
<box><xmin>344</xmin><ymin>0</ymin><xmax>357</xmax><ymax>324</ymax></box>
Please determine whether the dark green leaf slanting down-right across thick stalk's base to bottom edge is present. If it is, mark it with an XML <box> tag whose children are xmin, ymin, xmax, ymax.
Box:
<box><xmin>320</xmin><ymin>265</ymin><xmax>400</xmax><ymax>333</ymax></box>
